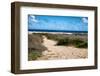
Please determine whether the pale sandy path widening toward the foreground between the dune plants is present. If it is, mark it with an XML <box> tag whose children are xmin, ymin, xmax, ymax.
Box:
<box><xmin>38</xmin><ymin>36</ymin><xmax>88</xmax><ymax>60</ymax></box>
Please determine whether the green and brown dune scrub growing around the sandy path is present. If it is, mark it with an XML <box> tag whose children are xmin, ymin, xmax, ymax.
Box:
<box><xmin>28</xmin><ymin>33</ymin><xmax>88</xmax><ymax>60</ymax></box>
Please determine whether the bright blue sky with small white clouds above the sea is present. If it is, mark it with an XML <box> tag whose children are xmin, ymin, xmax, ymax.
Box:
<box><xmin>28</xmin><ymin>14</ymin><xmax>88</xmax><ymax>31</ymax></box>
